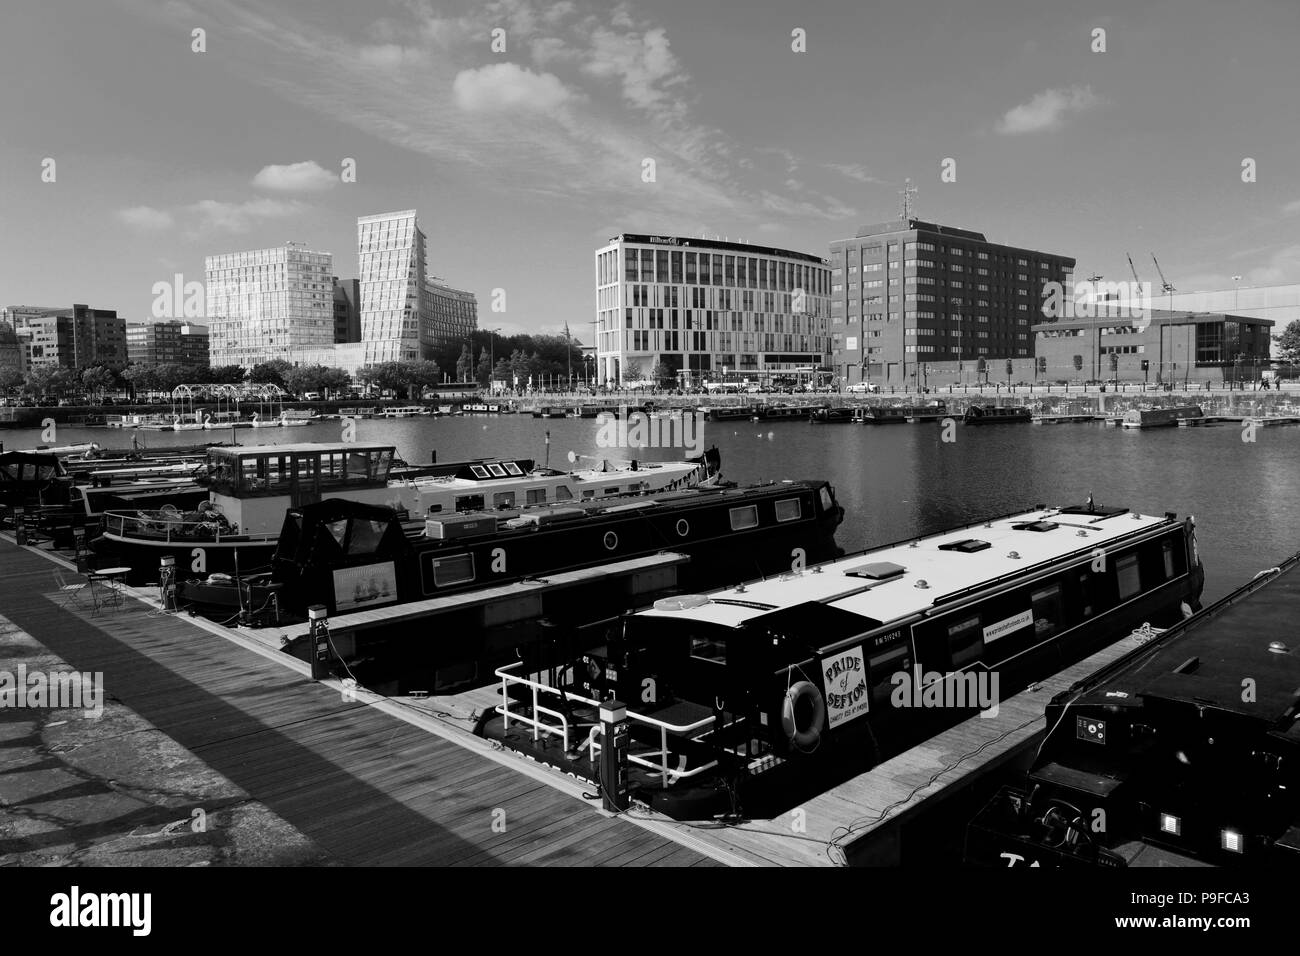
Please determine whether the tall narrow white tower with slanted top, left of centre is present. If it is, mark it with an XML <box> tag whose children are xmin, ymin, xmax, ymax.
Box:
<box><xmin>356</xmin><ymin>209</ymin><xmax>433</xmax><ymax>364</ymax></box>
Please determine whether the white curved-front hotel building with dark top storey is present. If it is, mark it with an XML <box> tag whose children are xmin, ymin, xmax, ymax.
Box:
<box><xmin>595</xmin><ymin>234</ymin><xmax>831</xmax><ymax>385</ymax></box>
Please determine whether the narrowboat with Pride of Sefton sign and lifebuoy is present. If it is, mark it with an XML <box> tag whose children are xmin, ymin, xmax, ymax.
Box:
<box><xmin>478</xmin><ymin>506</ymin><xmax>1204</xmax><ymax>818</ymax></box>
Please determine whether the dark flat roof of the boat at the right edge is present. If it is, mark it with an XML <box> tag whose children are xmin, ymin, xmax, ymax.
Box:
<box><xmin>1078</xmin><ymin>555</ymin><xmax>1300</xmax><ymax>723</ymax></box>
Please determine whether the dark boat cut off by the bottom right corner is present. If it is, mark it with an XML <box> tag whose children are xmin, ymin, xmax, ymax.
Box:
<box><xmin>966</xmin><ymin>554</ymin><xmax>1300</xmax><ymax>870</ymax></box>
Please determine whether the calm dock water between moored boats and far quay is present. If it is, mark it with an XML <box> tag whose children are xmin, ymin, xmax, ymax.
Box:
<box><xmin>0</xmin><ymin>415</ymin><xmax>1300</xmax><ymax>600</ymax></box>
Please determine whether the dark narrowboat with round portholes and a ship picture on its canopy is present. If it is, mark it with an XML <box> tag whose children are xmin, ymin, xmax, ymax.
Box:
<box><xmin>272</xmin><ymin>481</ymin><xmax>844</xmax><ymax>615</ymax></box>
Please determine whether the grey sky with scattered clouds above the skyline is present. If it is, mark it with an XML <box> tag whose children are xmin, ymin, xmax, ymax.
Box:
<box><xmin>0</xmin><ymin>0</ymin><xmax>1300</xmax><ymax>338</ymax></box>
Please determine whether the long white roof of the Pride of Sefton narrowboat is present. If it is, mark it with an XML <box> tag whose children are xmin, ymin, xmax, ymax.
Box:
<box><xmin>640</xmin><ymin>507</ymin><xmax>1171</xmax><ymax>630</ymax></box>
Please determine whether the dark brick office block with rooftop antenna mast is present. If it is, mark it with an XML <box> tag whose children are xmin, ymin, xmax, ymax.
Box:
<box><xmin>831</xmin><ymin>219</ymin><xmax>1074</xmax><ymax>385</ymax></box>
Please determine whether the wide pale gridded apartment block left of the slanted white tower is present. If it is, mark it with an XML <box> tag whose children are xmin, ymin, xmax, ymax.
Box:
<box><xmin>205</xmin><ymin>243</ymin><xmax>334</xmax><ymax>368</ymax></box>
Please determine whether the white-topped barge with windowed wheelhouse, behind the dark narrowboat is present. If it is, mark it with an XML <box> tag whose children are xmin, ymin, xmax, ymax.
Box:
<box><xmin>91</xmin><ymin>442</ymin><xmax>722</xmax><ymax>584</ymax></box>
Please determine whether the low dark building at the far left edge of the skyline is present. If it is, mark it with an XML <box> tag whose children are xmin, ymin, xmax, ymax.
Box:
<box><xmin>0</xmin><ymin>304</ymin><xmax>126</xmax><ymax>371</ymax></box>
